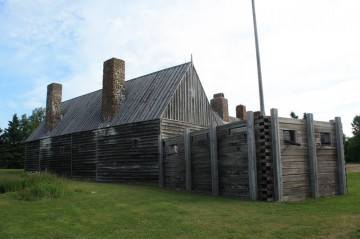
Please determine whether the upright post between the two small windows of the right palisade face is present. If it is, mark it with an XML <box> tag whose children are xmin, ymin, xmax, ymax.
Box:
<box><xmin>306</xmin><ymin>114</ymin><xmax>319</xmax><ymax>198</ymax></box>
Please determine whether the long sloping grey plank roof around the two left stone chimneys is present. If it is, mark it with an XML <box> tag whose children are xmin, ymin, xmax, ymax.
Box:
<box><xmin>27</xmin><ymin>63</ymin><xmax>192</xmax><ymax>141</ymax></box>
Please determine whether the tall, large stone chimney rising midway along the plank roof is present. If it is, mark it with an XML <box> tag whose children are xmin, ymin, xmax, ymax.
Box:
<box><xmin>101</xmin><ymin>58</ymin><xmax>125</xmax><ymax>122</ymax></box>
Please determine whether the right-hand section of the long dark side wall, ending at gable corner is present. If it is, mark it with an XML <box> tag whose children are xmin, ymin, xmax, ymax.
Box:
<box><xmin>96</xmin><ymin>120</ymin><xmax>160</xmax><ymax>184</ymax></box>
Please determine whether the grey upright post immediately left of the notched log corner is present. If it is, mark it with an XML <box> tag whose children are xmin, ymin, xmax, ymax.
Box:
<box><xmin>246</xmin><ymin>111</ymin><xmax>257</xmax><ymax>200</ymax></box>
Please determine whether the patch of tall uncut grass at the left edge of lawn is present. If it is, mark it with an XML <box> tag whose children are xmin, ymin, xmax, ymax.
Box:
<box><xmin>0</xmin><ymin>173</ymin><xmax>69</xmax><ymax>201</ymax></box>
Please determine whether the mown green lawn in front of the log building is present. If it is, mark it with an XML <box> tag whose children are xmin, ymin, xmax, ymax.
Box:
<box><xmin>0</xmin><ymin>170</ymin><xmax>360</xmax><ymax>238</ymax></box>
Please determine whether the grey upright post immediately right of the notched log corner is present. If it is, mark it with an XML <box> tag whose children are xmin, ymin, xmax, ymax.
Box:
<box><xmin>271</xmin><ymin>109</ymin><xmax>283</xmax><ymax>201</ymax></box>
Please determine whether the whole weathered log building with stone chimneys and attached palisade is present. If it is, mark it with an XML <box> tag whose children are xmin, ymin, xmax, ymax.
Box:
<box><xmin>25</xmin><ymin>58</ymin><xmax>346</xmax><ymax>201</ymax></box>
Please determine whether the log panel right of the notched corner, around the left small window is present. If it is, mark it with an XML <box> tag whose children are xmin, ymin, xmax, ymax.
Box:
<box><xmin>279</xmin><ymin>118</ymin><xmax>311</xmax><ymax>201</ymax></box>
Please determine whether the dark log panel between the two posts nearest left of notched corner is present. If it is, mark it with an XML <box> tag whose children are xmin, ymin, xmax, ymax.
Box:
<box><xmin>217</xmin><ymin>121</ymin><xmax>250</xmax><ymax>199</ymax></box>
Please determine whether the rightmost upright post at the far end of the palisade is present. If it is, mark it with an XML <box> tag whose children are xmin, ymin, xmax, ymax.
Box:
<box><xmin>335</xmin><ymin>117</ymin><xmax>347</xmax><ymax>194</ymax></box>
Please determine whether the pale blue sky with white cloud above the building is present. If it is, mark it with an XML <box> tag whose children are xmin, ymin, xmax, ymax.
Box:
<box><xmin>0</xmin><ymin>0</ymin><xmax>360</xmax><ymax>135</ymax></box>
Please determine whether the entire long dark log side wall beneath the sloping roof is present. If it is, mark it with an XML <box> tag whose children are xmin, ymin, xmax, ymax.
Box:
<box><xmin>25</xmin><ymin>120</ymin><xmax>160</xmax><ymax>184</ymax></box>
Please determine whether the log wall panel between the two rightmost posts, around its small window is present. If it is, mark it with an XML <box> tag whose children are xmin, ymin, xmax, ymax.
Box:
<box><xmin>314</xmin><ymin>121</ymin><xmax>340</xmax><ymax>196</ymax></box>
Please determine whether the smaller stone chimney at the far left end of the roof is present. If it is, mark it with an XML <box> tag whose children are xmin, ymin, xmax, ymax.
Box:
<box><xmin>45</xmin><ymin>83</ymin><xmax>62</xmax><ymax>131</ymax></box>
